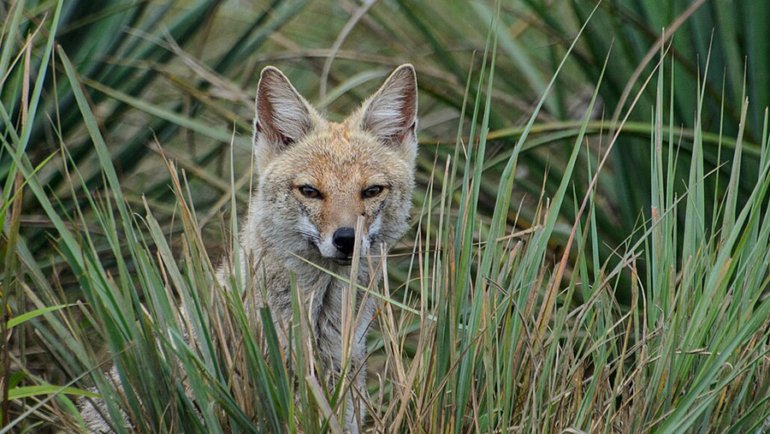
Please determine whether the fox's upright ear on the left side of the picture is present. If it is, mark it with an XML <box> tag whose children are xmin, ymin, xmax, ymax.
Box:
<box><xmin>254</xmin><ymin>66</ymin><xmax>313</xmax><ymax>147</ymax></box>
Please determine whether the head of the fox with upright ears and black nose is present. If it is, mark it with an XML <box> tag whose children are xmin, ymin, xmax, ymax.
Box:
<box><xmin>250</xmin><ymin>64</ymin><xmax>417</xmax><ymax>265</ymax></box>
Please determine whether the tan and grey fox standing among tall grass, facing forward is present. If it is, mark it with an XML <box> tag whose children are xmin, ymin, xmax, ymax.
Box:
<box><xmin>81</xmin><ymin>64</ymin><xmax>418</xmax><ymax>434</ymax></box>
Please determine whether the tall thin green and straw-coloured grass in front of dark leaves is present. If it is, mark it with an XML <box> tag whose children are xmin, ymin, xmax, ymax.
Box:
<box><xmin>0</xmin><ymin>2</ymin><xmax>770</xmax><ymax>433</ymax></box>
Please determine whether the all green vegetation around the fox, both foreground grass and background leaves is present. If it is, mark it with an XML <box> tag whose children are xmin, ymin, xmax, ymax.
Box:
<box><xmin>0</xmin><ymin>0</ymin><xmax>770</xmax><ymax>433</ymax></box>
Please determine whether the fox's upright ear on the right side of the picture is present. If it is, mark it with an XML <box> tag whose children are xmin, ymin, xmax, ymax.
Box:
<box><xmin>362</xmin><ymin>64</ymin><xmax>417</xmax><ymax>152</ymax></box>
